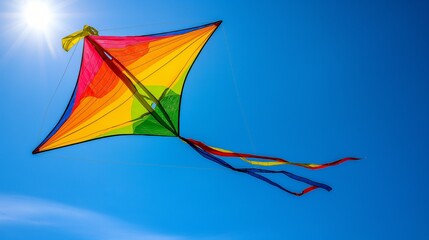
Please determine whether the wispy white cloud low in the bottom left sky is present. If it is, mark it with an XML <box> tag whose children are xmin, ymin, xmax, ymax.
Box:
<box><xmin>0</xmin><ymin>195</ymin><xmax>184</xmax><ymax>240</ymax></box>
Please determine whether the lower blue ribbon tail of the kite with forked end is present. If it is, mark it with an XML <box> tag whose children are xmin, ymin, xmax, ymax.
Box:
<box><xmin>180</xmin><ymin>137</ymin><xmax>332</xmax><ymax>196</ymax></box>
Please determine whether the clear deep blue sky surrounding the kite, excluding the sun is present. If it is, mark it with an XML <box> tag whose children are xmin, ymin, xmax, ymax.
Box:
<box><xmin>0</xmin><ymin>0</ymin><xmax>429</xmax><ymax>239</ymax></box>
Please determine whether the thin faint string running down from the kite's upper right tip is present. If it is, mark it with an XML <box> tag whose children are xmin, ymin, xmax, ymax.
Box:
<box><xmin>221</xmin><ymin>25</ymin><xmax>255</xmax><ymax>151</ymax></box>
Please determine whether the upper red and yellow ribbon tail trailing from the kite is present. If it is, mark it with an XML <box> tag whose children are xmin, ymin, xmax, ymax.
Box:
<box><xmin>187</xmin><ymin>139</ymin><xmax>359</xmax><ymax>170</ymax></box>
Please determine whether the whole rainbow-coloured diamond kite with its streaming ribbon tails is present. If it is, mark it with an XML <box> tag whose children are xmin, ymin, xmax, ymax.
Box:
<box><xmin>33</xmin><ymin>21</ymin><xmax>358</xmax><ymax>196</ymax></box>
